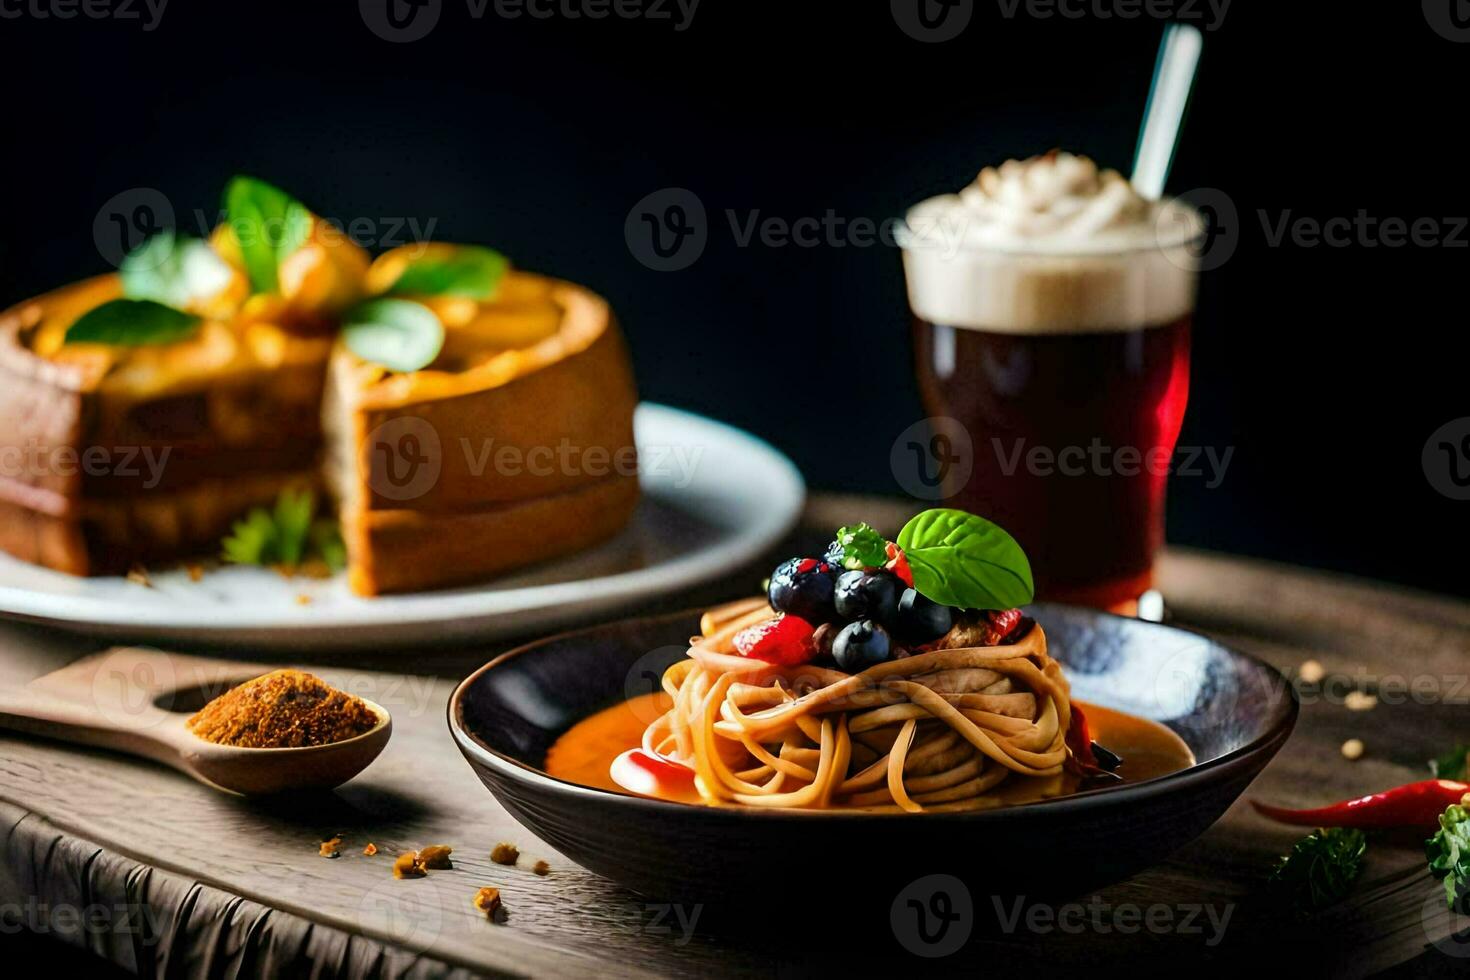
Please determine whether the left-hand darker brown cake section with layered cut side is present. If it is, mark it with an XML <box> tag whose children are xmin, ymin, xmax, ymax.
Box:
<box><xmin>0</xmin><ymin>275</ymin><xmax>331</xmax><ymax>574</ymax></box>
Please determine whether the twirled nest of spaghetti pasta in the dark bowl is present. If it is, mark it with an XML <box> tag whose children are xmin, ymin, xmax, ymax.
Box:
<box><xmin>642</xmin><ymin>599</ymin><xmax>1072</xmax><ymax>813</ymax></box>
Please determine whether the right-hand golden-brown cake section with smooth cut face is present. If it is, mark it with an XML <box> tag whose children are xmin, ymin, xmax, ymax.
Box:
<box><xmin>323</xmin><ymin>245</ymin><xmax>638</xmax><ymax>595</ymax></box>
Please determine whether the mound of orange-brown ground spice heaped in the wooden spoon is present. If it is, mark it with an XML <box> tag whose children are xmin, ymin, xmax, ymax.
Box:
<box><xmin>188</xmin><ymin>670</ymin><xmax>378</xmax><ymax>748</ymax></box>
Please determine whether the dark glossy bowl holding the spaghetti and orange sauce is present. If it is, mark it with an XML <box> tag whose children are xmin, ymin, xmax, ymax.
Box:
<box><xmin>448</xmin><ymin>604</ymin><xmax>1298</xmax><ymax>905</ymax></box>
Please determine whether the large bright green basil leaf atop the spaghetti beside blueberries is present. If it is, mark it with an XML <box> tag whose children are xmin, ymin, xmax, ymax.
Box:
<box><xmin>898</xmin><ymin>507</ymin><xmax>1036</xmax><ymax>610</ymax></box>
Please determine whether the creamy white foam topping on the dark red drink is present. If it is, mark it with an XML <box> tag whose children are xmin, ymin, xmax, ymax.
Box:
<box><xmin>903</xmin><ymin>151</ymin><xmax>1202</xmax><ymax>334</ymax></box>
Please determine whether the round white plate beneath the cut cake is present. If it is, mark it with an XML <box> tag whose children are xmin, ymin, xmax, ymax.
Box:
<box><xmin>0</xmin><ymin>404</ymin><xmax>806</xmax><ymax>648</ymax></box>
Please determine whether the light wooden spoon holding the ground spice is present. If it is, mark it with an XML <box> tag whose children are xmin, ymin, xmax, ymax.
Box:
<box><xmin>0</xmin><ymin>648</ymin><xmax>392</xmax><ymax>795</ymax></box>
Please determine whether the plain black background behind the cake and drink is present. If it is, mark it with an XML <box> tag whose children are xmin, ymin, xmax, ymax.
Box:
<box><xmin>0</xmin><ymin>0</ymin><xmax>1470</xmax><ymax>594</ymax></box>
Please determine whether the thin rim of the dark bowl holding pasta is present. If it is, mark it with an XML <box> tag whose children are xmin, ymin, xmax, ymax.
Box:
<box><xmin>445</xmin><ymin>602</ymin><xmax>1301</xmax><ymax>821</ymax></box>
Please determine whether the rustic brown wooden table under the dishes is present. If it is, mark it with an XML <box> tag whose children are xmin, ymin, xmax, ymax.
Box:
<box><xmin>0</xmin><ymin>497</ymin><xmax>1470</xmax><ymax>977</ymax></box>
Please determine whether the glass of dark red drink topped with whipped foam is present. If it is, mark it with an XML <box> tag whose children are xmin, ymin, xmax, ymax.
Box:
<box><xmin>903</xmin><ymin>153</ymin><xmax>1202</xmax><ymax>611</ymax></box>
